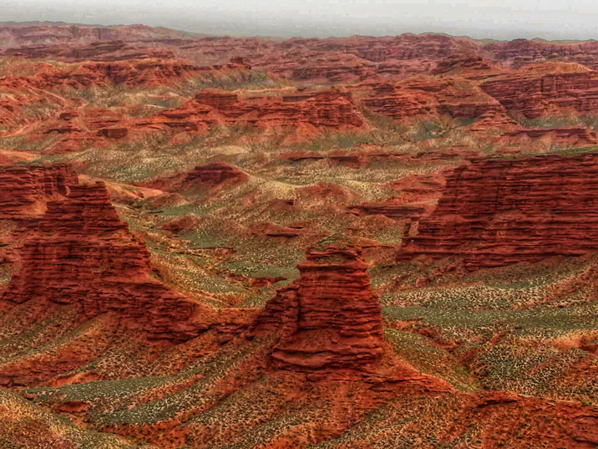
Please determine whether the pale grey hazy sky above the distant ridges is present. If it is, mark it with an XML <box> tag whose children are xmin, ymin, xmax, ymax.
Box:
<box><xmin>0</xmin><ymin>0</ymin><xmax>598</xmax><ymax>39</ymax></box>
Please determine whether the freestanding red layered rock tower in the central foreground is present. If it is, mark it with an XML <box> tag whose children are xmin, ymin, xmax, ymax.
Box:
<box><xmin>253</xmin><ymin>247</ymin><xmax>383</xmax><ymax>370</ymax></box>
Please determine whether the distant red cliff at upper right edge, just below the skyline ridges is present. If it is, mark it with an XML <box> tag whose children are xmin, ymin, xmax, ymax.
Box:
<box><xmin>481</xmin><ymin>63</ymin><xmax>598</xmax><ymax>118</ymax></box>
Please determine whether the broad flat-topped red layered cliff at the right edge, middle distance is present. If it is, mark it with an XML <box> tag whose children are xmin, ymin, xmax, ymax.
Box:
<box><xmin>400</xmin><ymin>154</ymin><xmax>598</xmax><ymax>270</ymax></box>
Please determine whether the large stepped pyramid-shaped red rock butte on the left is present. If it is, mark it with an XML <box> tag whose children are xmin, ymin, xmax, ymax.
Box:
<box><xmin>1</xmin><ymin>183</ymin><xmax>202</xmax><ymax>341</ymax></box>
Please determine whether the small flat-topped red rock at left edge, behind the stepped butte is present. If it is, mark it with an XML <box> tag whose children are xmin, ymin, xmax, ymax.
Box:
<box><xmin>0</xmin><ymin>164</ymin><xmax>78</xmax><ymax>219</ymax></box>
